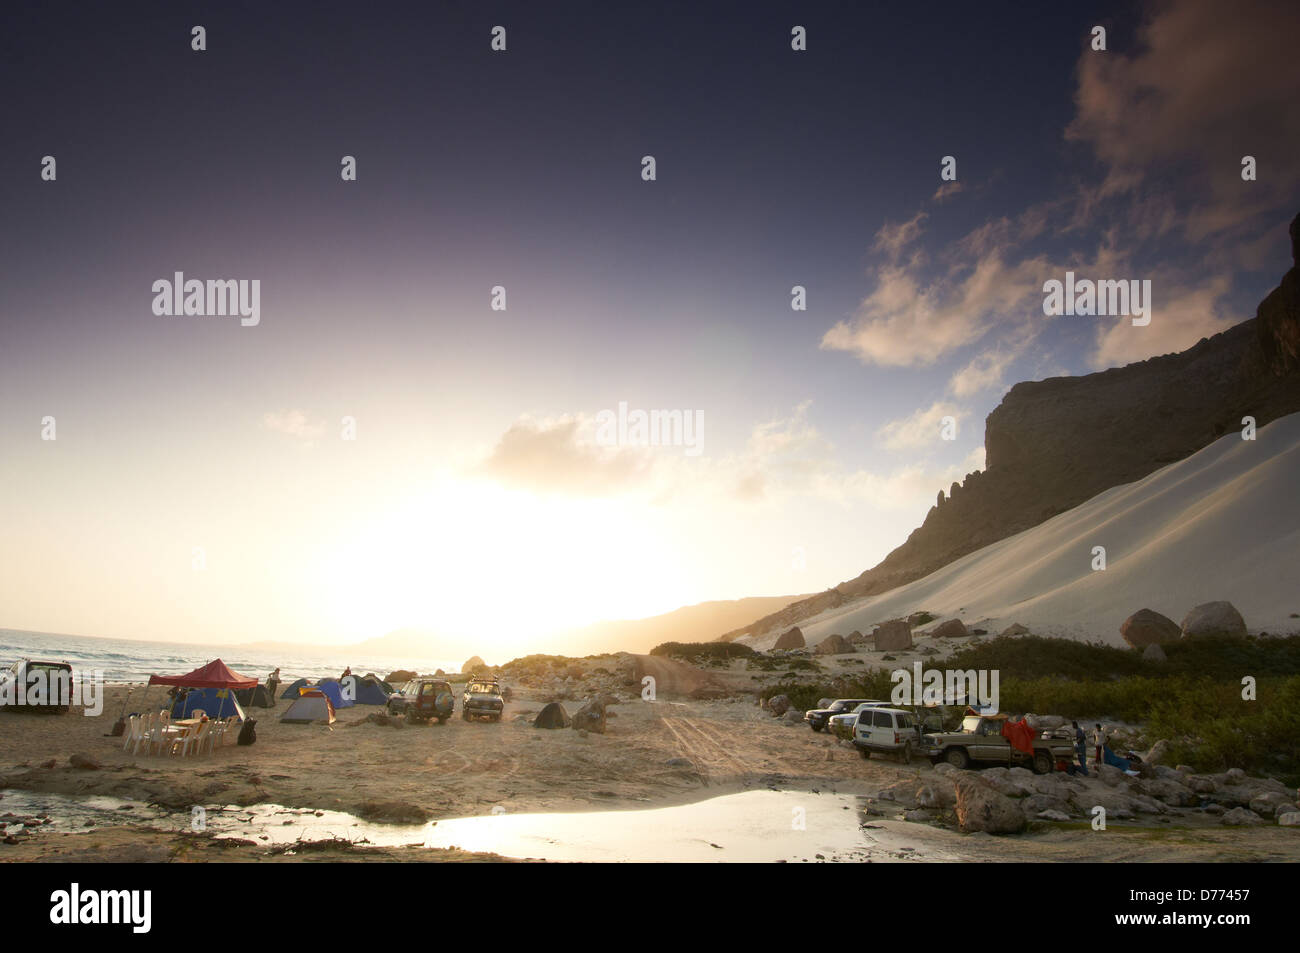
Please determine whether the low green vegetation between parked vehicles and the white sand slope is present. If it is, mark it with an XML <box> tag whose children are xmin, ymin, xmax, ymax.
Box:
<box><xmin>761</xmin><ymin>636</ymin><xmax>1300</xmax><ymax>785</ymax></box>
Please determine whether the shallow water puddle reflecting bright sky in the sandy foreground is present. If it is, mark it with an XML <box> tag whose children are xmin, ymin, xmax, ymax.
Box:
<box><xmin>0</xmin><ymin>790</ymin><xmax>958</xmax><ymax>863</ymax></box>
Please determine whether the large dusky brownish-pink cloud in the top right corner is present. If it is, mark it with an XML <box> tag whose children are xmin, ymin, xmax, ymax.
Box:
<box><xmin>1065</xmin><ymin>0</ymin><xmax>1300</xmax><ymax>241</ymax></box>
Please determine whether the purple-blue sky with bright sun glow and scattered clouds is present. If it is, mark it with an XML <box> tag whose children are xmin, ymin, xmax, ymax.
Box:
<box><xmin>0</xmin><ymin>0</ymin><xmax>1300</xmax><ymax>651</ymax></box>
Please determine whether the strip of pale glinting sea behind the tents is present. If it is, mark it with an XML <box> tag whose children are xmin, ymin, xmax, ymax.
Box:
<box><xmin>0</xmin><ymin>629</ymin><xmax>460</xmax><ymax>685</ymax></box>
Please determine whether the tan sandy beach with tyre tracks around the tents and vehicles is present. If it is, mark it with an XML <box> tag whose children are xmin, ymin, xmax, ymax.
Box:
<box><xmin>0</xmin><ymin>653</ymin><xmax>1300</xmax><ymax>862</ymax></box>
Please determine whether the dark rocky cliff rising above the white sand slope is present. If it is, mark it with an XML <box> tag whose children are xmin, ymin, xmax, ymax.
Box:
<box><xmin>720</xmin><ymin>215</ymin><xmax>1300</xmax><ymax>641</ymax></box>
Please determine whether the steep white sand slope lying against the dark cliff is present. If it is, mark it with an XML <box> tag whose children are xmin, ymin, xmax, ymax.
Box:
<box><xmin>742</xmin><ymin>413</ymin><xmax>1300</xmax><ymax>649</ymax></box>
